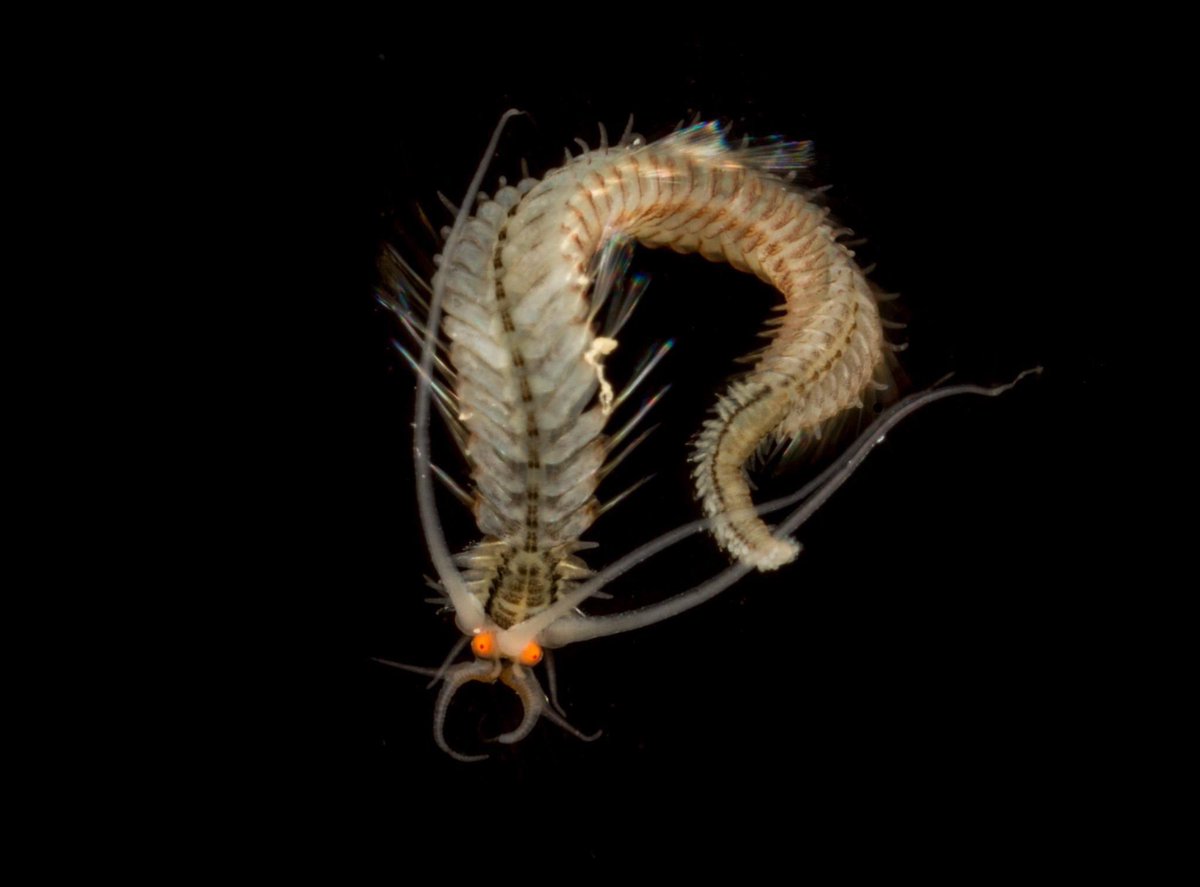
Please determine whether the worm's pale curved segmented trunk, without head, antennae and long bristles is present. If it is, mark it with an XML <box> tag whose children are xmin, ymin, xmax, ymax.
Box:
<box><xmin>442</xmin><ymin>126</ymin><xmax>883</xmax><ymax>627</ymax></box>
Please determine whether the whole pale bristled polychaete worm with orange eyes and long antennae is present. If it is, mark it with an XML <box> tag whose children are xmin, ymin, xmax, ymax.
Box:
<box><xmin>379</xmin><ymin>112</ymin><xmax>1034</xmax><ymax>761</ymax></box>
